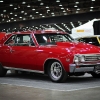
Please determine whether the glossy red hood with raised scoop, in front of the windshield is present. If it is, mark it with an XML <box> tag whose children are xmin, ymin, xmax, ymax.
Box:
<box><xmin>57</xmin><ymin>42</ymin><xmax>100</xmax><ymax>54</ymax></box>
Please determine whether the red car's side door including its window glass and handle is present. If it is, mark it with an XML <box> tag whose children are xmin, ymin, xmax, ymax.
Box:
<box><xmin>5</xmin><ymin>34</ymin><xmax>37</xmax><ymax>70</ymax></box>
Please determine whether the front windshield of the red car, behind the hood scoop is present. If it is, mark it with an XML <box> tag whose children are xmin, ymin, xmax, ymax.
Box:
<box><xmin>35</xmin><ymin>33</ymin><xmax>74</xmax><ymax>45</ymax></box>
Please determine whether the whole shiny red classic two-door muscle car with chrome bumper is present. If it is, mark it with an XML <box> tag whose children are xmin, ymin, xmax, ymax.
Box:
<box><xmin>0</xmin><ymin>30</ymin><xmax>100</xmax><ymax>82</ymax></box>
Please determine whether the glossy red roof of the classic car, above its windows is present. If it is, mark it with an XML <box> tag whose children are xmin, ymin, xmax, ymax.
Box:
<box><xmin>12</xmin><ymin>30</ymin><xmax>66</xmax><ymax>34</ymax></box>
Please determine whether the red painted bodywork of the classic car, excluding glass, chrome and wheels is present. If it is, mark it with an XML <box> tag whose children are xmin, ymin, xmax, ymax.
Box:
<box><xmin>0</xmin><ymin>31</ymin><xmax>100</xmax><ymax>71</ymax></box>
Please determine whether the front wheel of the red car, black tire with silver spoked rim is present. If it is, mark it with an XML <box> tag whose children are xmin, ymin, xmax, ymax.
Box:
<box><xmin>48</xmin><ymin>61</ymin><xmax>68</xmax><ymax>82</ymax></box>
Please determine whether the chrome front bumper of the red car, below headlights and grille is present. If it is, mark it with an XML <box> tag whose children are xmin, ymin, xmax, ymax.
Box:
<box><xmin>69</xmin><ymin>63</ymin><xmax>100</xmax><ymax>73</ymax></box>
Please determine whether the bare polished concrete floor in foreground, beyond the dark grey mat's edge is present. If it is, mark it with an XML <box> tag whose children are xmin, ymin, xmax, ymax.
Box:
<box><xmin>0</xmin><ymin>84</ymin><xmax>100</xmax><ymax>100</ymax></box>
